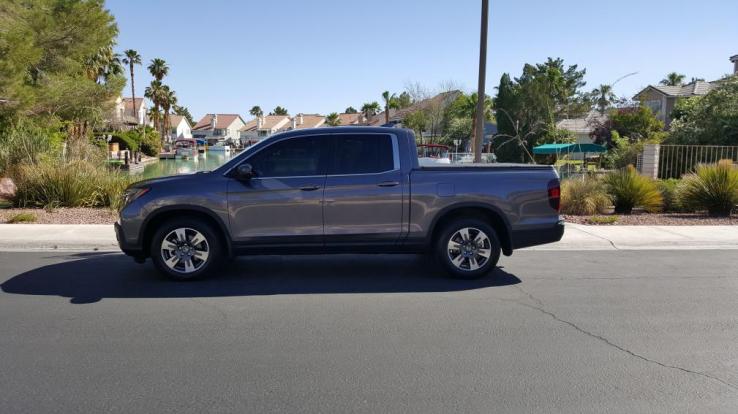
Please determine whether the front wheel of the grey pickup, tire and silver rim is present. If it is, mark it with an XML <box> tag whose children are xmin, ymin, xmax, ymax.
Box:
<box><xmin>149</xmin><ymin>218</ymin><xmax>225</xmax><ymax>280</ymax></box>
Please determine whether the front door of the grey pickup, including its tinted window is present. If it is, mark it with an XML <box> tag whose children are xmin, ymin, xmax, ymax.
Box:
<box><xmin>228</xmin><ymin>136</ymin><xmax>330</xmax><ymax>245</ymax></box>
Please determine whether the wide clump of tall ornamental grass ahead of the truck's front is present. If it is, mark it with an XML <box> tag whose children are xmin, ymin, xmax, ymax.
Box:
<box><xmin>14</xmin><ymin>160</ymin><xmax>131</xmax><ymax>208</ymax></box>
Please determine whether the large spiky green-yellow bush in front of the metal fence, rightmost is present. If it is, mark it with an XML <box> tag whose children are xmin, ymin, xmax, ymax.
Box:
<box><xmin>677</xmin><ymin>160</ymin><xmax>738</xmax><ymax>216</ymax></box>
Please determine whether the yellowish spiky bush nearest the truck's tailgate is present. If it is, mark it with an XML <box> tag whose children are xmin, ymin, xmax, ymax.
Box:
<box><xmin>561</xmin><ymin>175</ymin><xmax>610</xmax><ymax>216</ymax></box>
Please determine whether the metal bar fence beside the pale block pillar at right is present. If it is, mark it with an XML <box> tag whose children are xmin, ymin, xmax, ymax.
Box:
<box><xmin>658</xmin><ymin>145</ymin><xmax>738</xmax><ymax>179</ymax></box>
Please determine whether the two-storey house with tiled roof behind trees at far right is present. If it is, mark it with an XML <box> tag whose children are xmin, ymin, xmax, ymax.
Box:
<box><xmin>633</xmin><ymin>55</ymin><xmax>738</xmax><ymax>128</ymax></box>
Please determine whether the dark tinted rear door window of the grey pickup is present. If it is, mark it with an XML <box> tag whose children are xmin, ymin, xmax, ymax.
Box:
<box><xmin>329</xmin><ymin>134</ymin><xmax>395</xmax><ymax>174</ymax></box>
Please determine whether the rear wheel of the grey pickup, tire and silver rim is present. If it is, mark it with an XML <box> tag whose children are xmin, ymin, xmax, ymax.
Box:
<box><xmin>435</xmin><ymin>218</ymin><xmax>502</xmax><ymax>279</ymax></box>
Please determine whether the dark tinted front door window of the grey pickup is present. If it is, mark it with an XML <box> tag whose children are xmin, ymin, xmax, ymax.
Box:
<box><xmin>246</xmin><ymin>136</ymin><xmax>325</xmax><ymax>177</ymax></box>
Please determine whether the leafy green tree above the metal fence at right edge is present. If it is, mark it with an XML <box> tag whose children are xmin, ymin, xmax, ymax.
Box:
<box><xmin>666</xmin><ymin>76</ymin><xmax>738</xmax><ymax>146</ymax></box>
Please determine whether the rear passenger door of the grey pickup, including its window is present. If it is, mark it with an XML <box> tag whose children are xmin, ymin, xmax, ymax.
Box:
<box><xmin>323</xmin><ymin>133</ymin><xmax>404</xmax><ymax>245</ymax></box>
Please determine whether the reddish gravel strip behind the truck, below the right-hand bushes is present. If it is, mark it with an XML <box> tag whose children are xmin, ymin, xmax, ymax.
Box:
<box><xmin>562</xmin><ymin>213</ymin><xmax>738</xmax><ymax>226</ymax></box>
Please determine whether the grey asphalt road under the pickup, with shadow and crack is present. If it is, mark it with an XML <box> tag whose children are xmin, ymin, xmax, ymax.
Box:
<box><xmin>0</xmin><ymin>251</ymin><xmax>738</xmax><ymax>414</ymax></box>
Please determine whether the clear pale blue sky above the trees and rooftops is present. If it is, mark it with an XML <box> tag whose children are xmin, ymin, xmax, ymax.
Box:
<box><xmin>106</xmin><ymin>0</ymin><xmax>738</xmax><ymax>119</ymax></box>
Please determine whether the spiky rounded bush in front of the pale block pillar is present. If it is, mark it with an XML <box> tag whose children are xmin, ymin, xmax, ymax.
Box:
<box><xmin>605</xmin><ymin>165</ymin><xmax>663</xmax><ymax>214</ymax></box>
